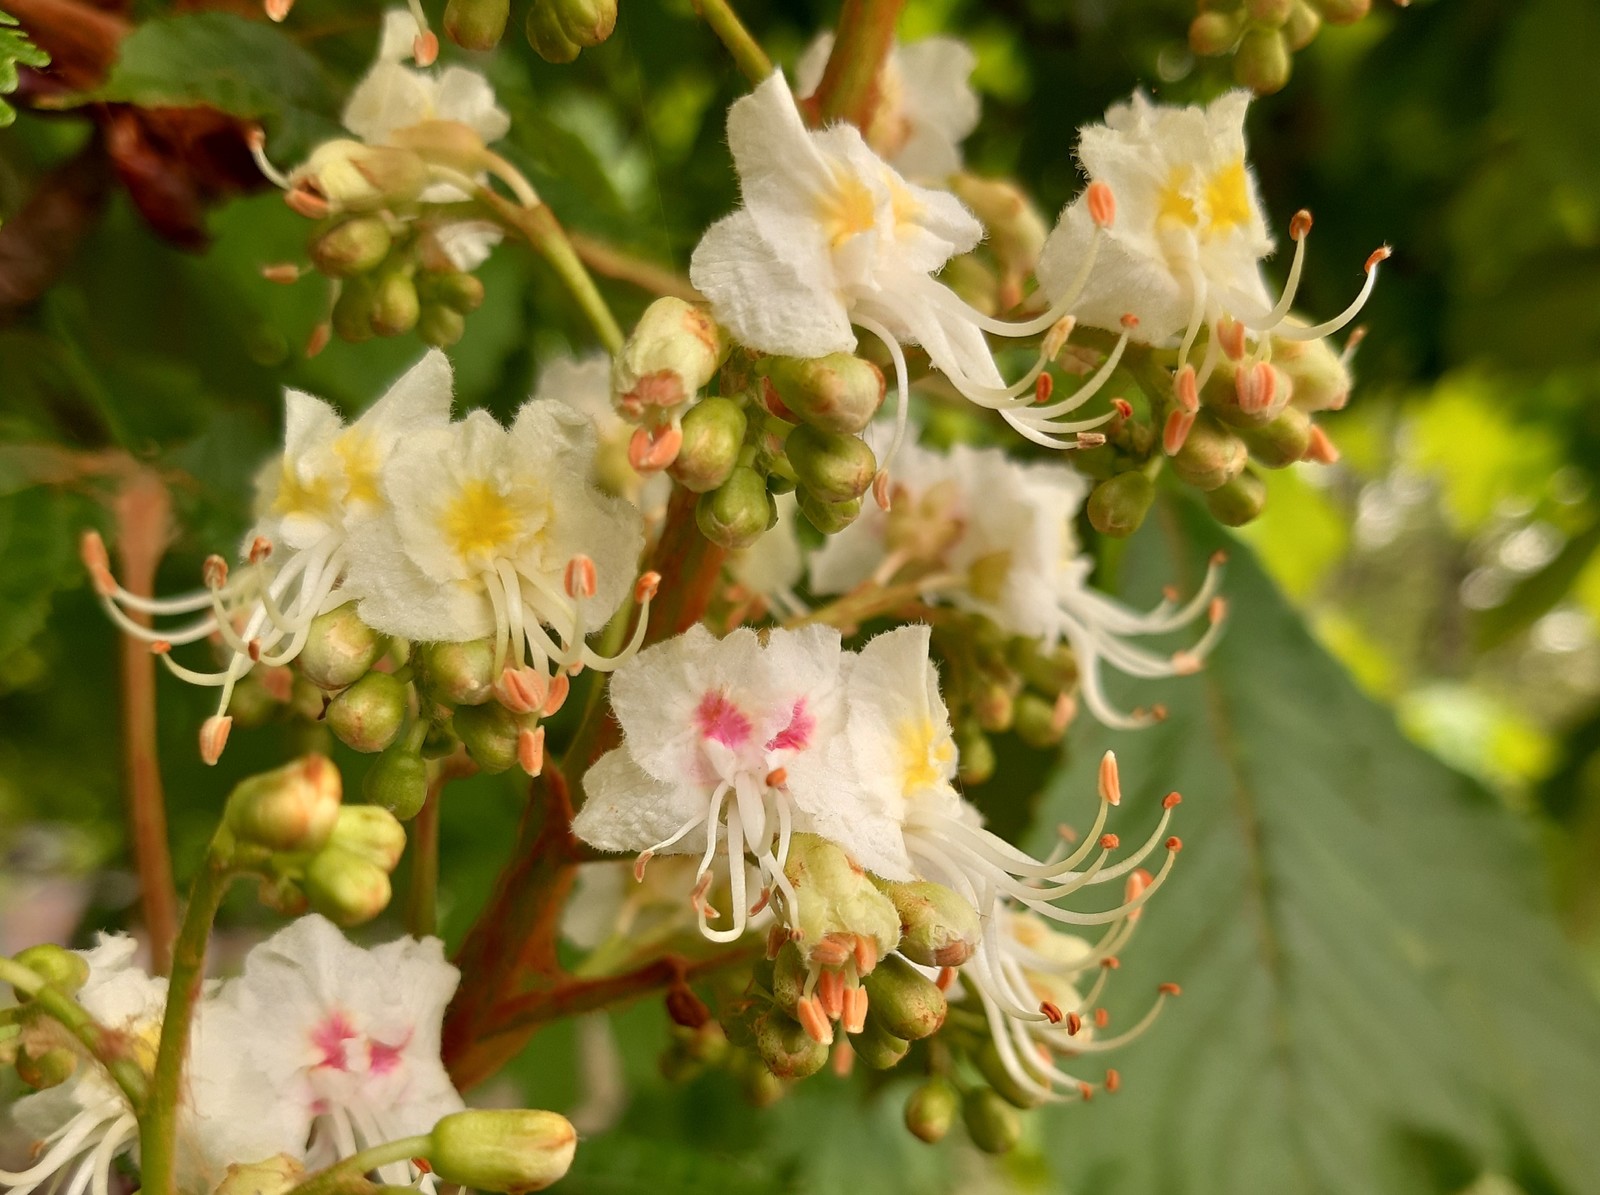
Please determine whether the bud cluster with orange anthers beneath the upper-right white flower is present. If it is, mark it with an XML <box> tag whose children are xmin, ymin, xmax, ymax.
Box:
<box><xmin>1078</xmin><ymin>310</ymin><xmax>1362</xmax><ymax>538</ymax></box>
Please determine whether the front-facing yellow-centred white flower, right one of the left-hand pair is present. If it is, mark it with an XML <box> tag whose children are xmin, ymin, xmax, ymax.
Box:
<box><xmin>349</xmin><ymin>402</ymin><xmax>654</xmax><ymax>729</ymax></box>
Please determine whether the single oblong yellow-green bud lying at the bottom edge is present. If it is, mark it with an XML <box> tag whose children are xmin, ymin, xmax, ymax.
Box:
<box><xmin>427</xmin><ymin>1109</ymin><xmax>578</xmax><ymax>1192</ymax></box>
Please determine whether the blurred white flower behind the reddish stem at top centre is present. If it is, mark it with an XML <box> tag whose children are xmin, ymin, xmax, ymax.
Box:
<box><xmin>795</xmin><ymin>34</ymin><xmax>979</xmax><ymax>179</ymax></box>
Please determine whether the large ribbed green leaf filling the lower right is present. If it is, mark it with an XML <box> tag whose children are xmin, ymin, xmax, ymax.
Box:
<box><xmin>1045</xmin><ymin>507</ymin><xmax>1600</xmax><ymax>1195</ymax></box>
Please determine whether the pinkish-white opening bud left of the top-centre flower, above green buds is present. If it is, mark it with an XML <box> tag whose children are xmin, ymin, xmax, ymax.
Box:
<box><xmin>611</xmin><ymin>297</ymin><xmax>728</xmax><ymax>419</ymax></box>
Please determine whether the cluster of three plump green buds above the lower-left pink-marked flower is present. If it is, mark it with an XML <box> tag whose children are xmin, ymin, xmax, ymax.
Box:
<box><xmin>222</xmin><ymin>755</ymin><xmax>405</xmax><ymax>926</ymax></box>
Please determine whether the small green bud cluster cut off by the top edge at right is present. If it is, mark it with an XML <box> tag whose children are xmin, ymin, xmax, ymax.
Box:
<box><xmin>1189</xmin><ymin>0</ymin><xmax>1388</xmax><ymax>96</ymax></box>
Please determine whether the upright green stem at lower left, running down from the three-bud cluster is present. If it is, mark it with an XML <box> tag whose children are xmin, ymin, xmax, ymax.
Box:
<box><xmin>139</xmin><ymin>830</ymin><xmax>234</xmax><ymax>1195</ymax></box>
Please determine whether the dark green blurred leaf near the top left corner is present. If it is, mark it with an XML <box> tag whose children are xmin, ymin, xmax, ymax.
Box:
<box><xmin>74</xmin><ymin>13</ymin><xmax>336</xmax><ymax>160</ymax></box>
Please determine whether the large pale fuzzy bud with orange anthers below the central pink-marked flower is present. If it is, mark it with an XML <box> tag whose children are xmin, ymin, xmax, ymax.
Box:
<box><xmin>784</xmin><ymin>833</ymin><xmax>899</xmax><ymax>974</ymax></box>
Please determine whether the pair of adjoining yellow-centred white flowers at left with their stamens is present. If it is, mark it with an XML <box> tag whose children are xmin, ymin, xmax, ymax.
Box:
<box><xmin>83</xmin><ymin>350</ymin><xmax>654</xmax><ymax>769</ymax></box>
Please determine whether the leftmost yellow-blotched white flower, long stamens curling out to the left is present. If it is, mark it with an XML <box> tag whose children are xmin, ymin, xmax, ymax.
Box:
<box><xmin>83</xmin><ymin>350</ymin><xmax>451</xmax><ymax>763</ymax></box>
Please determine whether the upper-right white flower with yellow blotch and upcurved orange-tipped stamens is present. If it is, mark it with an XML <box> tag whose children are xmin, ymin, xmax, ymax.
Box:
<box><xmin>1038</xmin><ymin>91</ymin><xmax>1389</xmax><ymax>451</ymax></box>
